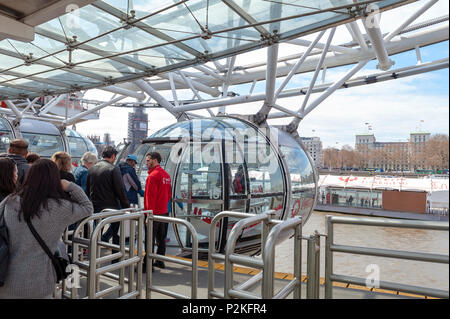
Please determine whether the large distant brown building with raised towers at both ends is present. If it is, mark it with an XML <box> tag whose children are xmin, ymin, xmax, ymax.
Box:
<box><xmin>355</xmin><ymin>132</ymin><xmax>430</xmax><ymax>171</ymax></box>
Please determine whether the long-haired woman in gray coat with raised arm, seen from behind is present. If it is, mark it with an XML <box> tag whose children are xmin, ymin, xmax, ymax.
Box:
<box><xmin>0</xmin><ymin>159</ymin><xmax>93</xmax><ymax>299</ymax></box>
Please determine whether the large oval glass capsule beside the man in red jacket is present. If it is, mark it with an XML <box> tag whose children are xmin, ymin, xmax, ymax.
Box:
<box><xmin>135</xmin><ymin>116</ymin><xmax>317</xmax><ymax>254</ymax></box>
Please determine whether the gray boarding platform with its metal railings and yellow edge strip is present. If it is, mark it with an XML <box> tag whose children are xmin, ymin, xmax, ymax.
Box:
<box><xmin>54</xmin><ymin>209</ymin><xmax>449</xmax><ymax>299</ymax></box>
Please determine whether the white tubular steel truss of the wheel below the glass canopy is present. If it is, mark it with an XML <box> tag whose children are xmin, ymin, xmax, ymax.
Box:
<box><xmin>0</xmin><ymin>0</ymin><xmax>449</xmax><ymax>133</ymax></box>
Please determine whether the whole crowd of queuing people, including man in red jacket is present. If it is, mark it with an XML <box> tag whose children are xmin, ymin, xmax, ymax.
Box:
<box><xmin>0</xmin><ymin>139</ymin><xmax>171</xmax><ymax>299</ymax></box>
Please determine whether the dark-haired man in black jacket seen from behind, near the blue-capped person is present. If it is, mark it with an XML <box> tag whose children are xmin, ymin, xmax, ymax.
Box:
<box><xmin>86</xmin><ymin>146</ymin><xmax>130</xmax><ymax>245</ymax></box>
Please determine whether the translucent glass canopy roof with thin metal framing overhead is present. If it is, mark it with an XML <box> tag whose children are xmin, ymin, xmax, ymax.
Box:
<box><xmin>0</xmin><ymin>0</ymin><xmax>416</xmax><ymax>99</ymax></box>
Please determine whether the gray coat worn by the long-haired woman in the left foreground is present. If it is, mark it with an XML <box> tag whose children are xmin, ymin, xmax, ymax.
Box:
<box><xmin>0</xmin><ymin>183</ymin><xmax>93</xmax><ymax>299</ymax></box>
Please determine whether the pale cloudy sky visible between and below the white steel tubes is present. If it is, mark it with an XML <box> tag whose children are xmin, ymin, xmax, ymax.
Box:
<box><xmin>76</xmin><ymin>0</ymin><xmax>449</xmax><ymax>148</ymax></box>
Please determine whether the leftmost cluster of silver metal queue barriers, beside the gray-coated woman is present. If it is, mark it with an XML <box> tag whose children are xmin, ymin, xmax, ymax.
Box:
<box><xmin>61</xmin><ymin>208</ymin><xmax>147</xmax><ymax>299</ymax></box>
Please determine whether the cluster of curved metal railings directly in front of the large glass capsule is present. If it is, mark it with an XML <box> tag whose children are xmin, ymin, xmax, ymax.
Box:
<box><xmin>208</xmin><ymin>211</ymin><xmax>302</xmax><ymax>299</ymax></box>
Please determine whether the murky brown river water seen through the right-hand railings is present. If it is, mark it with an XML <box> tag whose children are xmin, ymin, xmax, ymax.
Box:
<box><xmin>275</xmin><ymin>211</ymin><xmax>449</xmax><ymax>290</ymax></box>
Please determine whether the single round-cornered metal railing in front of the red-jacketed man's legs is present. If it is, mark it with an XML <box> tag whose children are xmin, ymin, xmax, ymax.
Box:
<box><xmin>146</xmin><ymin>214</ymin><xmax>198</xmax><ymax>299</ymax></box>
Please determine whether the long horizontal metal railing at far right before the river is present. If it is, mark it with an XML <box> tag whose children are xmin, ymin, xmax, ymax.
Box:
<box><xmin>325</xmin><ymin>215</ymin><xmax>449</xmax><ymax>299</ymax></box>
